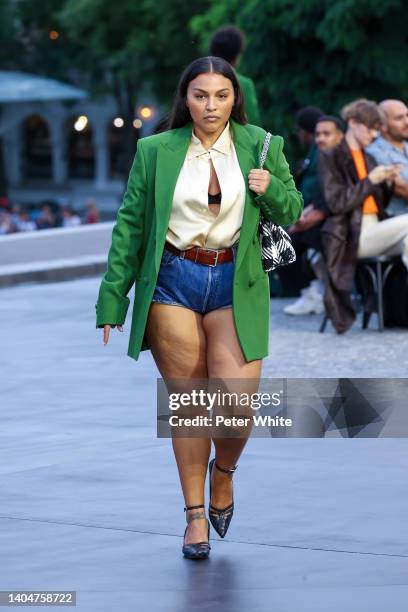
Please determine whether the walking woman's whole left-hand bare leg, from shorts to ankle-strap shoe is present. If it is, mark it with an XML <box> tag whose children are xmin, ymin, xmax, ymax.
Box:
<box><xmin>146</xmin><ymin>302</ymin><xmax>211</xmax><ymax>544</ymax></box>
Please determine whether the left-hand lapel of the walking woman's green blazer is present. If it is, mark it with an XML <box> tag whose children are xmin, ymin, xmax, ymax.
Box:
<box><xmin>155</xmin><ymin>123</ymin><xmax>192</xmax><ymax>270</ymax></box>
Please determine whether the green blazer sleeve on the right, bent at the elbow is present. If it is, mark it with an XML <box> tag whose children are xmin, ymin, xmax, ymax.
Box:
<box><xmin>255</xmin><ymin>136</ymin><xmax>303</xmax><ymax>225</ymax></box>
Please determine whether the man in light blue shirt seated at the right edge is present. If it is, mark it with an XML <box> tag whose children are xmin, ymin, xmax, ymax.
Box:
<box><xmin>366</xmin><ymin>100</ymin><xmax>408</xmax><ymax>216</ymax></box>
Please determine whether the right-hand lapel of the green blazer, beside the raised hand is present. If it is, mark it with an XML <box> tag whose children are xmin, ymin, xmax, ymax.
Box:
<box><xmin>230</xmin><ymin>119</ymin><xmax>259</xmax><ymax>270</ymax></box>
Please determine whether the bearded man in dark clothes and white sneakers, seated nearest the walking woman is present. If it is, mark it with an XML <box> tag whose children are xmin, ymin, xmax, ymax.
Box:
<box><xmin>277</xmin><ymin>115</ymin><xmax>344</xmax><ymax>315</ymax></box>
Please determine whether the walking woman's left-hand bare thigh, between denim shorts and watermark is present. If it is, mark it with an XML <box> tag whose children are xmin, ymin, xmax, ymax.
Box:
<box><xmin>146</xmin><ymin>302</ymin><xmax>207</xmax><ymax>378</ymax></box>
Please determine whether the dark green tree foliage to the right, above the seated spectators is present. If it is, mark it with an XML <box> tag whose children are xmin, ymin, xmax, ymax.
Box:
<box><xmin>191</xmin><ymin>0</ymin><xmax>408</xmax><ymax>152</ymax></box>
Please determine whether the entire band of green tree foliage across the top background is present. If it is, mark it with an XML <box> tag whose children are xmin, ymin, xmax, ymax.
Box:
<box><xmin>0</xmin><ymin>0</ymin><xmax>408</xmax><ymax>160</ymax></box>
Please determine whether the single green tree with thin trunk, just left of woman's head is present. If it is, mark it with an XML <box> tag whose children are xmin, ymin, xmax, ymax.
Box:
<box><xmin>59</xmin><ymin>0</ymin><xmax>208</xmax><ymax>172</ymax></box>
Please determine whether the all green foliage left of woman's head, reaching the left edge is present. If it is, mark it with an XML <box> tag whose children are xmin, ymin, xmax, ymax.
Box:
<box><xmin>0</xmin><ymin>0</ymin><xmax>209</xmax><ymax>173</ymax></box>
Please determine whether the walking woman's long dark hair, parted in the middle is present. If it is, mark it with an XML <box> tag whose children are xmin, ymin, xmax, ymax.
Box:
<box><xmin>168</xmin><ymin>55</ymin><xmax>248</xmax><ymax>130</ymax></box>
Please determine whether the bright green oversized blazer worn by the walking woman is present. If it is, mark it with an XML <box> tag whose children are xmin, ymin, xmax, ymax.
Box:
<box><xmin>95</xmin><ymin>119</ymin><xmax>303</xmax><ymax>361</ymax></box>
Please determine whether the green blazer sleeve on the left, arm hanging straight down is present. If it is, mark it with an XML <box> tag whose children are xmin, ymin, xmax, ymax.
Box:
<box><xmin>95</xmin><ymin>140</ymin><xmax>147</xmax><ymax>328</ymax></box>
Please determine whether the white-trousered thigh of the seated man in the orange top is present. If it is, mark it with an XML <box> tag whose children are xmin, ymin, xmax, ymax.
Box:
<box><xmin>358</xmin><ymin>214</ymin><xmax>408</xmax><ymax>257</ymax></box>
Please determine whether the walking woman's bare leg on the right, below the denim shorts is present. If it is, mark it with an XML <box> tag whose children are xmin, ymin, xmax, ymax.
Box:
<box><xmin>203</xmin><ymin>308</ymin><xmax>262</xmax><ymax>508</ymax></box>
